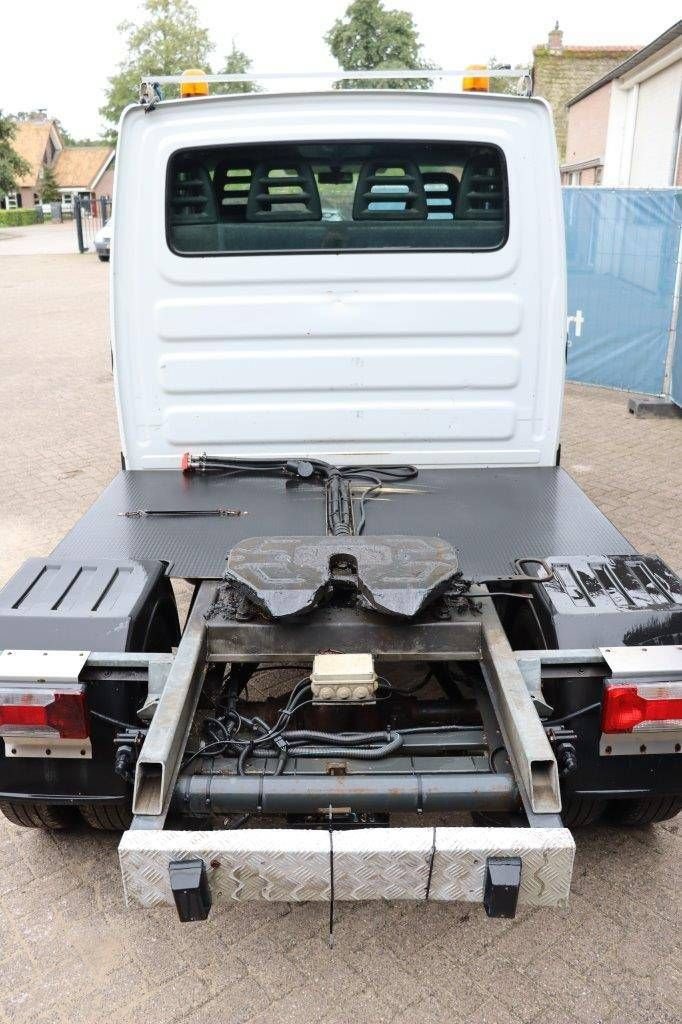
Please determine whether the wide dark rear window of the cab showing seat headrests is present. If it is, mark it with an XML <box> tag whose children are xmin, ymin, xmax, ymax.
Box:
<box><xmin>166</xmin><ymin>141</ymin><xmax>509</xmax><ymax>256</ymax></box>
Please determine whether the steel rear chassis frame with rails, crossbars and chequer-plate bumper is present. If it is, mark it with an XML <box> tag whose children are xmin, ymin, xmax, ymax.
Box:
<box><xmin>110</xmin><ymin>582</ymin><xmax>589</xmax><ymax>920</ymax></box>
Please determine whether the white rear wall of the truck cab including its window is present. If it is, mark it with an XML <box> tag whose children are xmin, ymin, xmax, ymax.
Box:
<box><xmin>112</xmin><ymin>90</ymin><xmax>565</xmax><ymax>469</ymax></box>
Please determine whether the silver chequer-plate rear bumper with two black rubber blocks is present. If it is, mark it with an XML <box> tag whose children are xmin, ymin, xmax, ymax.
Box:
<box><xmin>119</xmin><ymin>827</ymin><xmax>576</xmax><ymax>907</ymax></box>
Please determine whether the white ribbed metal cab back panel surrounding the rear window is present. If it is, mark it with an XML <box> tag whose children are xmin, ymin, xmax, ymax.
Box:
<box><xmin>112</xmin><ymin>90</ymin><xmax>565</xmax><ymax>469</ymax></box>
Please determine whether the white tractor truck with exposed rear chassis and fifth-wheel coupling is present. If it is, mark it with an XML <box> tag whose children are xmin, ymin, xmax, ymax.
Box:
<box><xmin>0</xmin><ymin>72</ymin><xmax>682</xmax><ymax>921</ymax></box>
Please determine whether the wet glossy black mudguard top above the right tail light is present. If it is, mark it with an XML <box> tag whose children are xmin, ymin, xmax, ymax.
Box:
<box><xmin>534</xmin><ymin>554</ymin><xmax>682</xmax><ymax>649</ymax></box>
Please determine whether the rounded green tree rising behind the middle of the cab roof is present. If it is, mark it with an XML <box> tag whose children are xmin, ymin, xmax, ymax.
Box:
<box><xmin>325</xmin><ymin>0</ymin><xmax>434</xmax><ymax>89</ymax></box>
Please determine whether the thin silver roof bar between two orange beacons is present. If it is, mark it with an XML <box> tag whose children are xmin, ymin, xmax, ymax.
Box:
<box><xmin>141</xmin><ymin>68</ymin><xmax>529</xmax><ymax>85</ymax></box>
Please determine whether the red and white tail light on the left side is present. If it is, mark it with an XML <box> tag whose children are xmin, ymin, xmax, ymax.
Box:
<box><xmin>0</xmin><ymin>684</ymin><xmax>90</xmax><ymax>739</ymax></box>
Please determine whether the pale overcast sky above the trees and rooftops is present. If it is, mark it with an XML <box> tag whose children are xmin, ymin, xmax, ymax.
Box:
<box><xmin>0</xmin><ymin>0</ymin><xmax>679</xmax><ymax>136</ymax></box>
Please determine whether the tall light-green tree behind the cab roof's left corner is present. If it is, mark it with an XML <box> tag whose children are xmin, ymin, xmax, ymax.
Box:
<box><xmin>99</xmin><ymin>0</ymin><xmax>213</xmax><ymax>141</ymax></box>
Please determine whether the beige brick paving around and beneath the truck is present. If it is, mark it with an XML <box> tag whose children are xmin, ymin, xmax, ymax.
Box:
<box><xmin>0</xmin><ymin>249</ymin><xmax>682</xmax><ymax>1024</ymax></box>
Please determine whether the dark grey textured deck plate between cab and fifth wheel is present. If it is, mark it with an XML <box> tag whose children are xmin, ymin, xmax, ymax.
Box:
<box><xmin>53</xmin><ymin>467</ymin><xmax>635</xmax><ymax>580</ymax></box>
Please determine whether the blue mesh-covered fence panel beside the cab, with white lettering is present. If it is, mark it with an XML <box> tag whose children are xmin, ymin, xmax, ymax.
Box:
<box><xmin>563</xmin><ymin>187</ymin><xmax>682</xmax><ymax>394</ymax></box>
